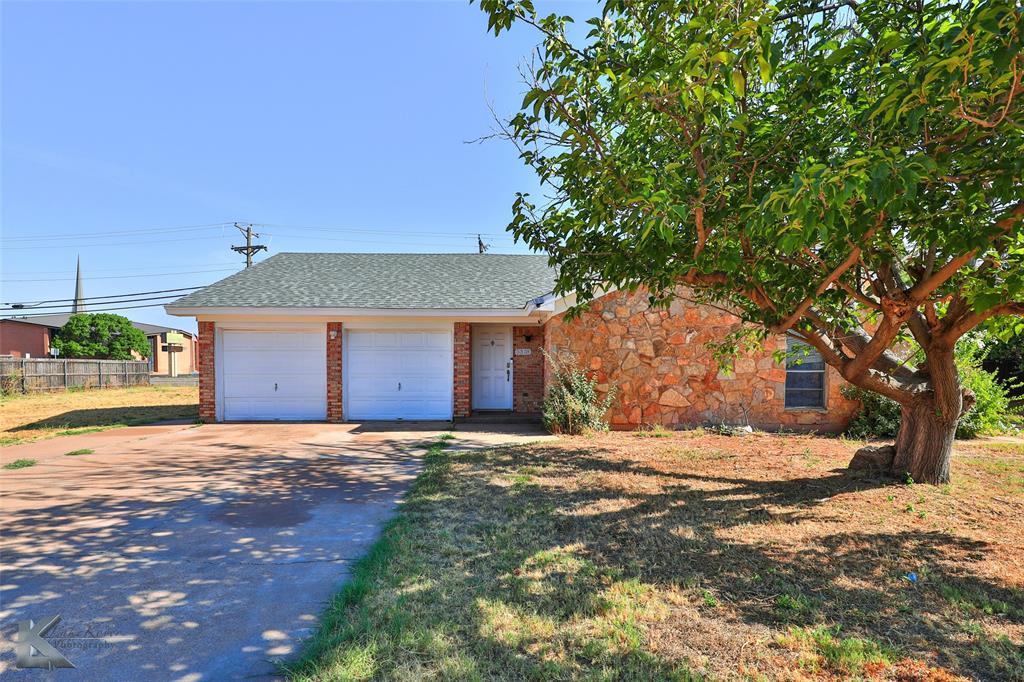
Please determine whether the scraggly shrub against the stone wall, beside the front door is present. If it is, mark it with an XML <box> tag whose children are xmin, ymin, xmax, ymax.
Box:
<box><xmin>541</xmin><ymin>352</ymin><xmax>614</xmax><ymax>433</ymax></box>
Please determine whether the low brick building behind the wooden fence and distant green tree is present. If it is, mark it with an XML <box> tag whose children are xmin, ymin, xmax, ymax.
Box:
<box><xmin>0</xmin><ymin>312</ymin><xmax>198</xmax><ymax>374</ymax></box>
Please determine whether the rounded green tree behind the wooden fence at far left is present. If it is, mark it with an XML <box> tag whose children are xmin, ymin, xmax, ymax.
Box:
<box><xmin>50</xmin><ymin>312</ymin><xmax>150</xmax><ymax>359</ymax></box>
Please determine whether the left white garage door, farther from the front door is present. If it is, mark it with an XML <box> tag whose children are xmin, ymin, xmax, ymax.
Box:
<box><xmin>220</xmin><ymin>330</ymin><xmax>327</xmax><ymax>420</ymax></box>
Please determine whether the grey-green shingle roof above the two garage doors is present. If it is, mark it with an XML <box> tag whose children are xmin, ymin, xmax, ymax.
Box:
<box><xmin>169</xmin><ymin>253</ymin><xmax>555</xmax><ymax>309</ymax></box>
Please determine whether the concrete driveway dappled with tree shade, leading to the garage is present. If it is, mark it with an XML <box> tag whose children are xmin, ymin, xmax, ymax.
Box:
<box><xmin>0</xmin><ymin>424</ymin><xmax>537</xmax><ymax>682</ymax></box>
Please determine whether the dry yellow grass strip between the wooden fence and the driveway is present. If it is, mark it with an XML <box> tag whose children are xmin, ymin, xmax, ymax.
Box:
<box><xmin>0</xmin><ymin>386</ymin><xmax>199</xmax><ymax>445</ymax></box>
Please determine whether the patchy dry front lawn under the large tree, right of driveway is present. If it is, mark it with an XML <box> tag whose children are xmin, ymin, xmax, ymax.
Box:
<box><xmin>295</xmin><ymin>432</ymin><xmax>1024</xmax><ymax>681</ymax></box>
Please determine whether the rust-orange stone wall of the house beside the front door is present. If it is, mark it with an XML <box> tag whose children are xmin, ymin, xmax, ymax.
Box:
<box><xmin>545</xmin><ymin>292</ymin><xmax>856</xmax><ymax>431</ymax></box>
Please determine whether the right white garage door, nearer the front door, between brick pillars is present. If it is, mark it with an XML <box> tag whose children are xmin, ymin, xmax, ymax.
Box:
<box><xmin>343</xmin><ymin>330</ymin><xmax>452</xmax><ymax>419</ymax></box>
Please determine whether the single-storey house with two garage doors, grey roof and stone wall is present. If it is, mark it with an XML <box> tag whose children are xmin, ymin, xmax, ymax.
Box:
<box><xmin>166</xmin><ymin>253</ymin><xmax>853</xmax><ymax>430</ymax></box>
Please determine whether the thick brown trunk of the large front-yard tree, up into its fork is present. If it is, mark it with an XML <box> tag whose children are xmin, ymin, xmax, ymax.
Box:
<box><xmin>892</xmin><ymin>348</ymin><xmax>974</xmax><ymax>483</ymax></box>
